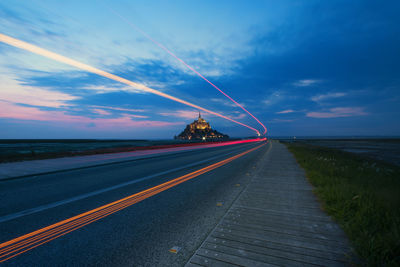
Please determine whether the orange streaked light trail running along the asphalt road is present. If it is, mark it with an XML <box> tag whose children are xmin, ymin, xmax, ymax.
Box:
<box><xmin>0</xmin><ymin>139</ymin><xmax>267</xmax><ymax>263</ymax></box>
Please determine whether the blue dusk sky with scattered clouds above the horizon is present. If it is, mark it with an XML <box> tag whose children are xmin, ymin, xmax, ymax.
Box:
<box><xmin>0</xmin><ymin>0</ymin><xmax>400</xmax><ymax>139</ymax></box>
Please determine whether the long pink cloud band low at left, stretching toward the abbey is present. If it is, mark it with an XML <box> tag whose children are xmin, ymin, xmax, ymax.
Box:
<box><xmin>0</xmin><ymin>102</ymin><xmax>184</xmax><ymax>128</ymax></box>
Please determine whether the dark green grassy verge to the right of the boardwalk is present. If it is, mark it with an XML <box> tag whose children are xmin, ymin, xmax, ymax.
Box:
<box><xmin>287</xmin><ymin>143</ymin><xmax>400</xmax><ymax>266</ymax></box>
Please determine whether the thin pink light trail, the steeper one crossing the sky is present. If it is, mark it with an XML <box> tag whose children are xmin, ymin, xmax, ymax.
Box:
<box><xmin>108</xmin><ymin>7</ymin><xmax>267</xmax><ymax>135</ymax></box>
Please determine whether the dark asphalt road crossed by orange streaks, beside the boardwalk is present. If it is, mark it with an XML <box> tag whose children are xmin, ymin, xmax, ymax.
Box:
<box><xmin>0</xmin><ymin>142</ymin><xmax>268</xmax><ymax>266</ymax></box>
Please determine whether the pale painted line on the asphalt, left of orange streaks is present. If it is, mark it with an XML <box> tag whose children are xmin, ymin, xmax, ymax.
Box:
<box><xmin>0</xmin><ymin>144</ymin><xmax>256</xmax><ymax>223</ymax></box>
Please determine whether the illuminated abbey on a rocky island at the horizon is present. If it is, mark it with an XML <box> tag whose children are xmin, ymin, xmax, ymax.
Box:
<box><xmin>175</xmin><ymin>112</ymin><xmax>229</xmax><ymax>141</ymax></box>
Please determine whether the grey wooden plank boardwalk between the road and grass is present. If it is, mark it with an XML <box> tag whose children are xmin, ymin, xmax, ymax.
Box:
<box><xmin>186</xmin><ymin>142</ymin><xmax>353</xmax><ymax>266</ymax></box>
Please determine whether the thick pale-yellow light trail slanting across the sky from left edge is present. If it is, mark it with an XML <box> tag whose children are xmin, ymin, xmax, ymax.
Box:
<box><xmin>0</xmin><ymin>33</ymin><xmax>259</xmax><ymax>134</ymax></box>
